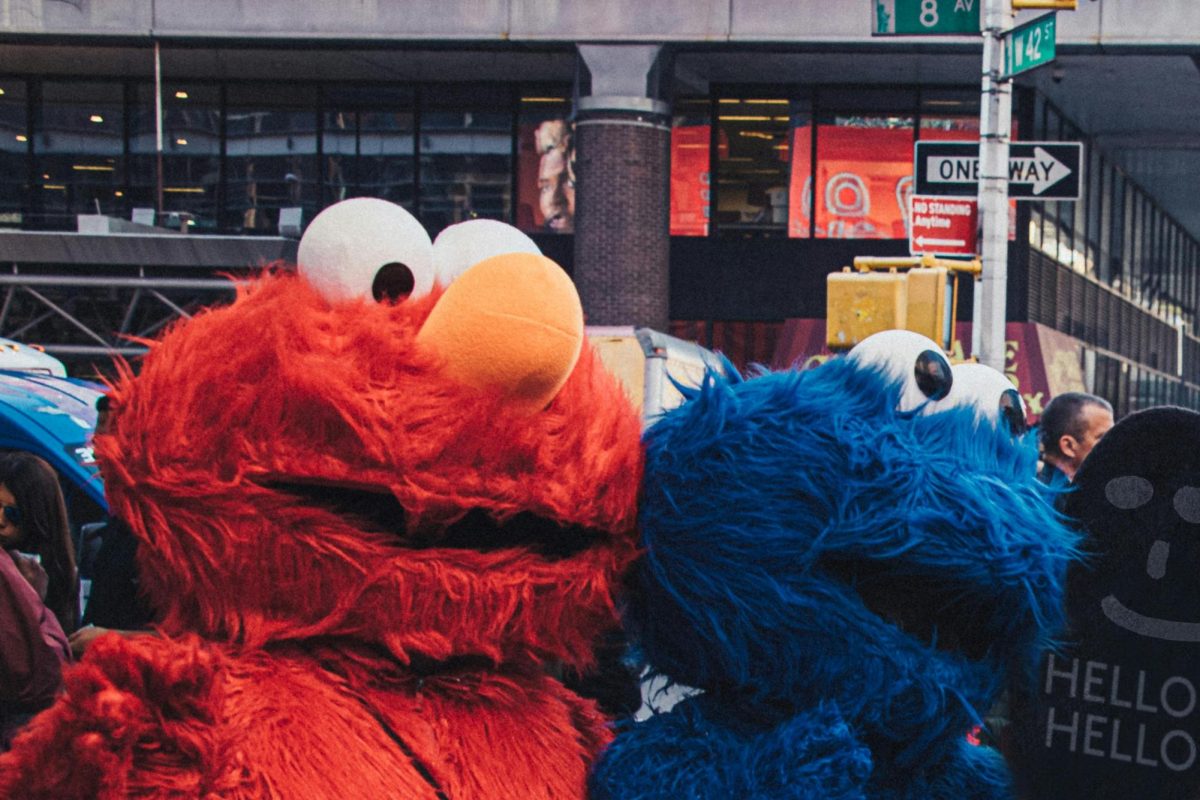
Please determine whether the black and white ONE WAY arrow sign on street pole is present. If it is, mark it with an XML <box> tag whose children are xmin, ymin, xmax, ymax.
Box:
<box><xmin>913</xmin><ymin>142</ymin><xmax>1084</xmax><ymax>200</ymax></box>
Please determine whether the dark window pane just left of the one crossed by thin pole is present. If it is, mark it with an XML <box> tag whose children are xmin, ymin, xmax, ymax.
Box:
<box><xmin>34</xmin><ymin>82</ymin><xmax>126</xmax><ymax>228</ymax></box>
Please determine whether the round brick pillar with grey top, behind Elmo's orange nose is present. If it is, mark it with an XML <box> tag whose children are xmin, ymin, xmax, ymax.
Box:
<box><xmin>575</xmin><ymin>44</ymin><xmax>671</xmax><ymax>331</ymax></box>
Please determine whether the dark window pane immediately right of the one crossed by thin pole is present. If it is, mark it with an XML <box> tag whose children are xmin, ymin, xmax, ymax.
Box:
<box><xmin>223</xmin><ymin>84</ymin><xmax>319</xmax><ymax>234</ymax></box>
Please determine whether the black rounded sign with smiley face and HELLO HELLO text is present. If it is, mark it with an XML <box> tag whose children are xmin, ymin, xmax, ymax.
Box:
<box><xmin>1008</xmin><ymin>408</ymin><xmax>1200</xmax><ymax>800</ymax></box>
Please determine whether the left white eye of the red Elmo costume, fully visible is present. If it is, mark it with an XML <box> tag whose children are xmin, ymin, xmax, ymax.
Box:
<box><xmin>296</xmin><ymin>197</ymin><xmax>433</xmax><ymax>302</ymax></box>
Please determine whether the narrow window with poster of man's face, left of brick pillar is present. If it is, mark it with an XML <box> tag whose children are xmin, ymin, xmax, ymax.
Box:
<box><xmin>517</xmin><ymin>91</ymin><xmax>571</xmax><ymax>234</ymax></box>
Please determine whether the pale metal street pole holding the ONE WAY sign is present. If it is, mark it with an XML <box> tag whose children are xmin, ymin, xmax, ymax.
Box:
<box><xmin>971</xmin><ymin>0</ymin><xmax>1013</xmax><ymax>372</ymax></box>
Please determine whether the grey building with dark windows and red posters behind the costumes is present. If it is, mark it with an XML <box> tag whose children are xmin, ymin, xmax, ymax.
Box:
<box><xmin>0</xmin><ymin>0</ymin><xmax>1200</xmax><ymax>413</ymax></box>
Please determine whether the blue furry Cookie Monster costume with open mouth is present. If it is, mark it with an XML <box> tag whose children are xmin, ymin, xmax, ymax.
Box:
<box><xmin>592</xmin><ymin>332</ymin><xmax>1075</xmax><ymax>800</ymax></box>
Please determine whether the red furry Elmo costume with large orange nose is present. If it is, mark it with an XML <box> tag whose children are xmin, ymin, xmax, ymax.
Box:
<box><xmin>0</xmin><ymin>200</ymin><xmax>641</xmax><ymax>800</ymax></box>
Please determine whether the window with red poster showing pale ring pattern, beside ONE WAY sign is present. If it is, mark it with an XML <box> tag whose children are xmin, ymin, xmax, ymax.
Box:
<box><xmin>814</xmin><ymin>114</ymin><xmax>913</xmax><ymax>239</ymax></box>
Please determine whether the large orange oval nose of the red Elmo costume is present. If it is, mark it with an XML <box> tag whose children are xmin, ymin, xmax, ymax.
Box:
<box><xmin>418</xmin><ymin>253</ymin><xmax>583</xmax><ymax>410</ymax></box>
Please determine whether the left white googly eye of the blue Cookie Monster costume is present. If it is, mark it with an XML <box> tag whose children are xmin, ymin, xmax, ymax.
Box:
<box><xmin>850</xmin><ymin>331</ymin><xmax>954</xmax><ymax>411</ymax></box>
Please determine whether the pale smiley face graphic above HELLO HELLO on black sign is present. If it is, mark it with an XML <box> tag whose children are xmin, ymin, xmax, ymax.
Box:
<box><xmin>1100</xmin><ymin>475</ymin><xmax>1200</xmax><ymax>642</ymax></box>
